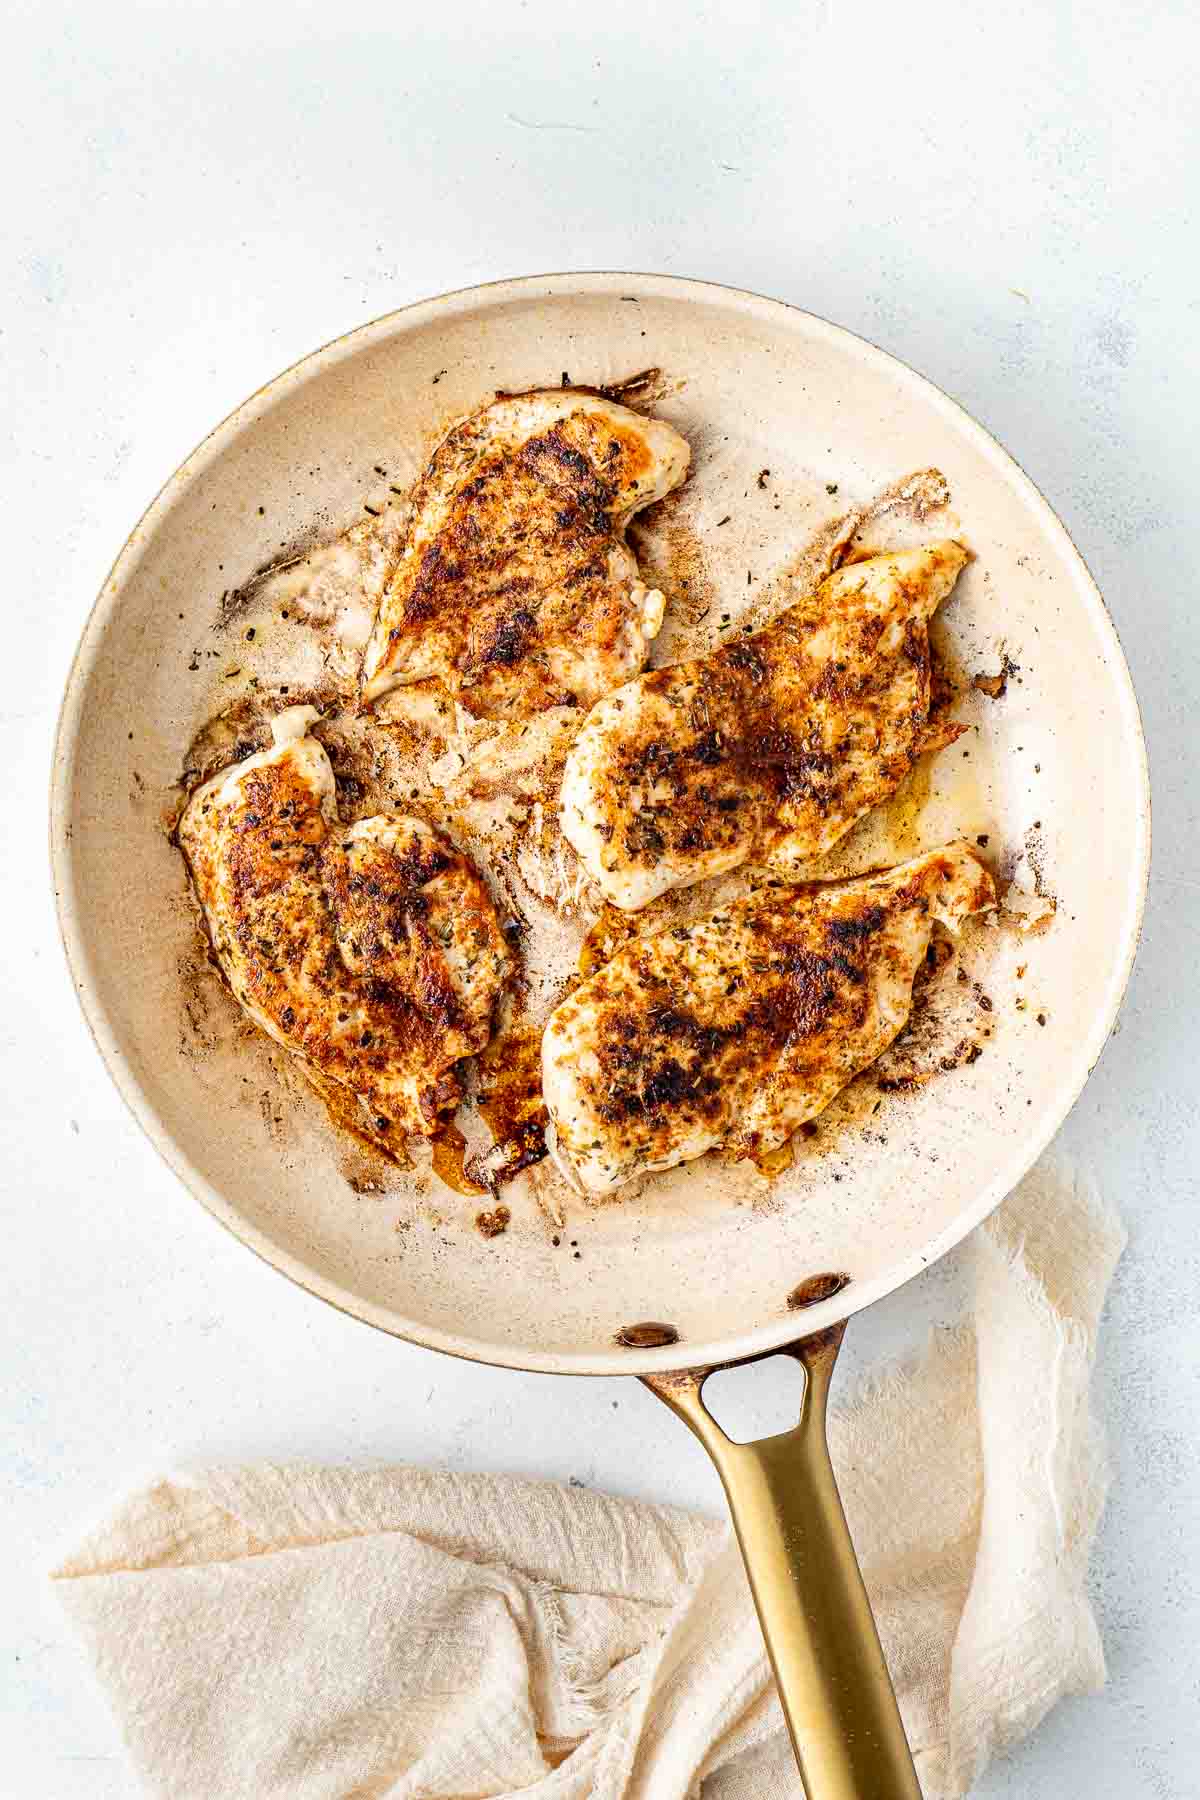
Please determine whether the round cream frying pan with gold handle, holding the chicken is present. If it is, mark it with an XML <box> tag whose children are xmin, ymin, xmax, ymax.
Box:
<box><xmin>52</xmin><ymin>274</ymin><xmax>1150</xmax><ymax>1800</ymax></box>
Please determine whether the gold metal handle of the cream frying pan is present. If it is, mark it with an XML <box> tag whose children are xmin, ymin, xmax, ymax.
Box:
<box><xmin>642</xmin><ymin>1325</ymin><xmax>921</xmax><ymax>1800</ymax></box>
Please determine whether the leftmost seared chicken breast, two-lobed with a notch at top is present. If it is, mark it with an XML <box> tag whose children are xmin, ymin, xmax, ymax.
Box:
<box><xmin>178</xmin><ymin>706</ymin><xmax>509</xmax><ymax>1134</ymax></box>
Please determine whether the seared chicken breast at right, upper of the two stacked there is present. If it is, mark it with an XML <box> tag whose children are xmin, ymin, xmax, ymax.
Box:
<box><xmin>560</xmin><ymin>540</ymin><xmax>966</xmax><ymax>911</ymax></box>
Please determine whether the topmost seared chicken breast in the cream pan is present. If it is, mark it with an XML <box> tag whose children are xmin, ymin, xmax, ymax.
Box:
<box><xmin>363</xmin><ymin>387</ymin><xmax>691</xmax><ymax>718</ymax></box>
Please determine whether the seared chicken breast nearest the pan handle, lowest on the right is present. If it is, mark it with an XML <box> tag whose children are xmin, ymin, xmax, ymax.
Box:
<box><xmin>542</xmin><ymin>844</ymin><xmax>995</xmax><ymax>1193</ymax></box>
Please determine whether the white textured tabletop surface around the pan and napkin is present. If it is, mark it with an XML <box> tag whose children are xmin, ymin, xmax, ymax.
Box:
<box><xmin>0</xmin><ymin>0</ymin><xmax>1200</xmax><ymax>1800</ymax></box>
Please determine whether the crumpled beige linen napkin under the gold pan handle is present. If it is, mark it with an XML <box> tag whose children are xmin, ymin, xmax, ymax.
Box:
<box><xmin>56</xmin><ymin>1165</ymin><xmax>1123</xmax><ymax>1800</ymax></box>
